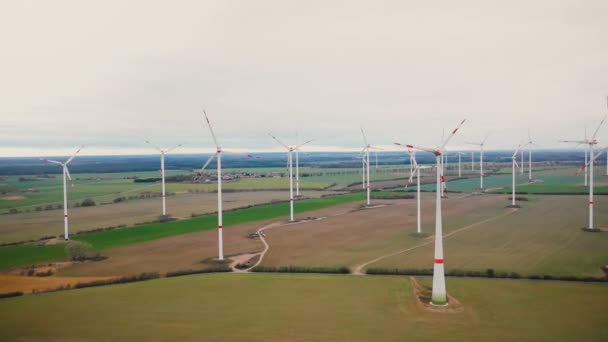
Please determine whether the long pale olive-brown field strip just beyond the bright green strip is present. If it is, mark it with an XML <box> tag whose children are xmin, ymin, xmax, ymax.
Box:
<box><xmin>0</xmin><ymin>191</ymin><xmax>330</xmax><ymax>243</ymax></box>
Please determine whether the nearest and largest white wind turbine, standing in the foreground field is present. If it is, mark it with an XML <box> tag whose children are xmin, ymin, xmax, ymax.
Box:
<box><xmin>406</xmin><ymin>120</ymin><xmax>465</xmax><ymax>305</ymax></box>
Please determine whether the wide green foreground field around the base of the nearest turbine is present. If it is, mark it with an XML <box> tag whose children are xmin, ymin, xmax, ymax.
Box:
<box><xmin>0</xmin><ymin>274</ymin><xmax>608</xmax><ymax>341</ymax></box>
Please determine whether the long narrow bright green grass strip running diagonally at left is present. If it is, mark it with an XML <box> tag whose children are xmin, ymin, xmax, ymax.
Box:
<box><xmin>0</xmin><ymin>193</ymin><xmax>364</xmax><ymax>270</ymax></box>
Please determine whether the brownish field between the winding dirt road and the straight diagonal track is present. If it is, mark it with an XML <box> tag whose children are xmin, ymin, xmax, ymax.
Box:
<box><xmin>262</xmin><ymin>193</ymin><xmax>507</xmax><ymax>268</ymax></box>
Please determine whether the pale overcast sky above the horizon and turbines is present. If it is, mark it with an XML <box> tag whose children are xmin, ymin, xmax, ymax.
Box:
<box><xmin>0</xmin><ymin>0</ymin><xmax>608</xmax><ymax>156</ymax></box>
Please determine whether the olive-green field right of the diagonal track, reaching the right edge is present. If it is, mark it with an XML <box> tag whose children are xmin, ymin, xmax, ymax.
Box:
<box><xmin>369</xmin><ymin>195</ymin><xmax>608</xmax><ymax>277</ymax></box>
